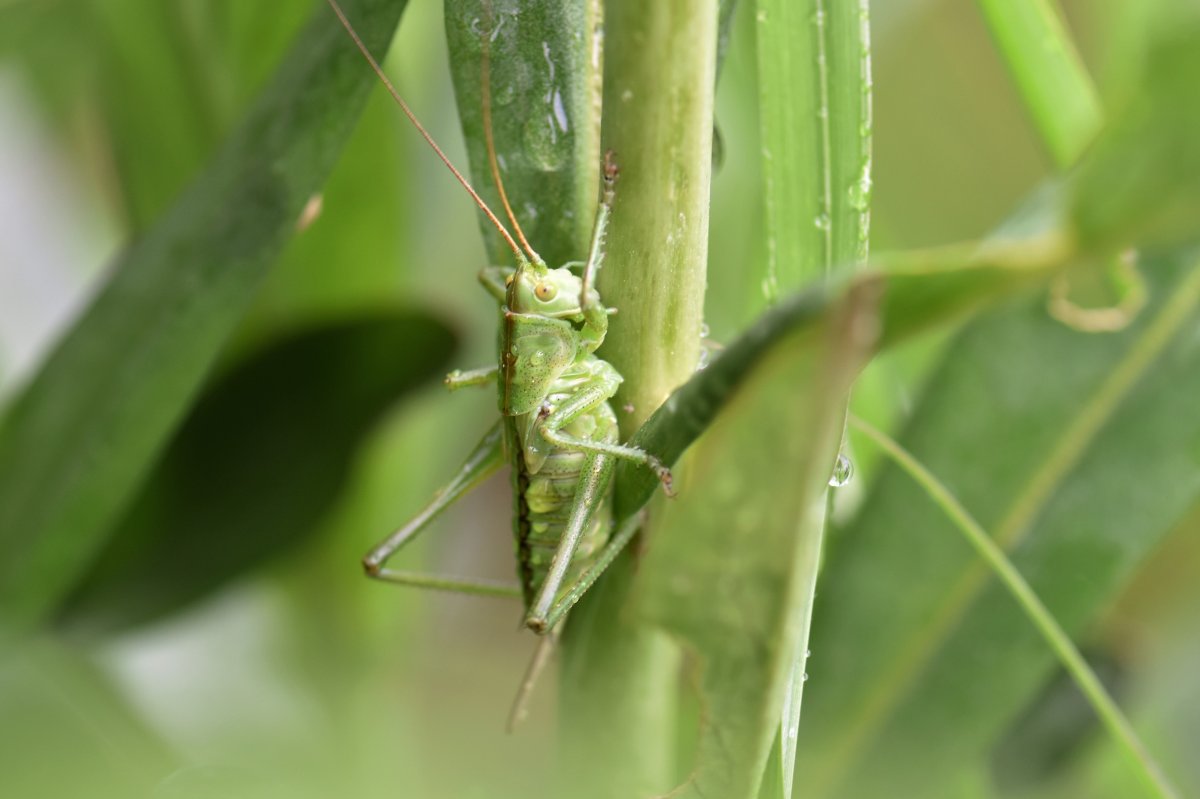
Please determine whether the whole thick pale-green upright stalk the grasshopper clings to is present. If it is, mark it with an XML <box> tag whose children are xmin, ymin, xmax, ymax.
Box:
<box><xmin>560</xmin><ymin>0</ymin><xmax>718</xmax><ymax>799</ymax></box>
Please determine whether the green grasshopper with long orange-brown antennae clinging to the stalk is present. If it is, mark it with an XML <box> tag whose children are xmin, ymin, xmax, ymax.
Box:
<box><xmin>328</xmin><ymin>0</ymin><xmax>671</xmax><ymax>633</ymax></box>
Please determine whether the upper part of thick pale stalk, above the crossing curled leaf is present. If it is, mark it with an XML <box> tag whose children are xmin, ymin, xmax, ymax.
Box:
<box><xmin>600</xmin><ymin>0</ymin><xmax>716</xmax><ymax>422</ymax></box>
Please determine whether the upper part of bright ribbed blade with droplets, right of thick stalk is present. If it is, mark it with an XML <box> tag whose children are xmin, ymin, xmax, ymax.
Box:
<box><xmin>756</xmin><ymin>0</ymin><xmax>871</xmax><ymax>301</ymax></box>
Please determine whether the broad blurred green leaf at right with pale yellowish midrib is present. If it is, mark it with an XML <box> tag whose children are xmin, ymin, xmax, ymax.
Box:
<box><xmin>798</xmin><ymin>252</ymin><xmax>1200</xmax><ymax>799</ymax></box>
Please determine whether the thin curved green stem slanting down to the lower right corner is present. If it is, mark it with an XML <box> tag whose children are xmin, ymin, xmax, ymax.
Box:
<box><xmin>850</xmin><ymin>415</ymin><xmax>1178</xmax><ymax>799</ymax></box>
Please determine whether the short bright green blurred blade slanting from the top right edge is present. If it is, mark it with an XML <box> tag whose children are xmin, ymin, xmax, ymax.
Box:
<box><xmin>978</xmin><ymin>0</ymin><xmax>1103</xmax><ymax>169</ymax></box>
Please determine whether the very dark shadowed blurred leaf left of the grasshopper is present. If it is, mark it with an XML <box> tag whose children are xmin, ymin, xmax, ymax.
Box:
<box><xmin>51</xmin><ymin>312</ymin><xmax>454</xmax><ymax>629</ymax></box>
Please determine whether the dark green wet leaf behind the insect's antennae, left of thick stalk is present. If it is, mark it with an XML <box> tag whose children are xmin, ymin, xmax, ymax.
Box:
<box><xmin>445</xmin><ymin>0</ymin><xmax>601</xmax><ymax>266</ymax></box>
